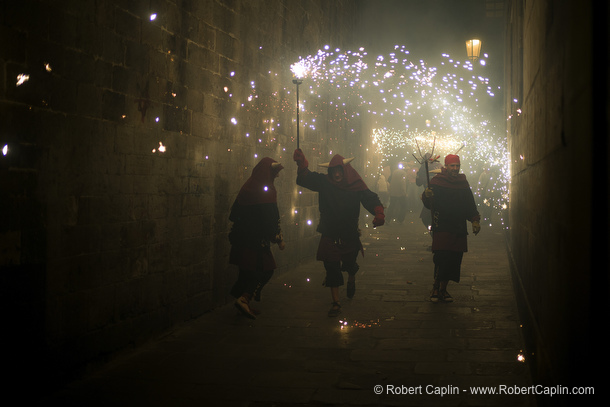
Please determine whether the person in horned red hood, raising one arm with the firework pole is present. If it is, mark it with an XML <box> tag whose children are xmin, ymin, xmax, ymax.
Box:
<box><xmin>293</xmin><ymin>149</ymin><xmax>385</xmax><ymax>317</ymax></box>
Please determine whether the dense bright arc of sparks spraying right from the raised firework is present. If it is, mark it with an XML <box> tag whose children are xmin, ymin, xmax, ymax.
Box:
<box><xmin>284</xmin><ymin>46</ymin><xmax>504</xmax><ymax>220</ymax></box>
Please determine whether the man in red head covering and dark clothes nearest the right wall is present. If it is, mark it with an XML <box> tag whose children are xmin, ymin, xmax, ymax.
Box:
<box><xmin>422</xmin><ymin>154</ymin><xmax>481</xmax><ymax>302</ymax></box>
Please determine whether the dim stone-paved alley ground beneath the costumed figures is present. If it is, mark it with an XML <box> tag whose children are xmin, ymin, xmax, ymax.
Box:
<box><xmin>39</xmin><ymin>213</ymin><xmax>536</xmax><ymax>407</ymax></box>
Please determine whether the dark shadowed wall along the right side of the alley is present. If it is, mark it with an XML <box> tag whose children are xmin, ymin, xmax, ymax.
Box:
<box><xmin>498</xmin><ymin>1</ymin><xmax>608</xmax><ymax>396</ymax></box>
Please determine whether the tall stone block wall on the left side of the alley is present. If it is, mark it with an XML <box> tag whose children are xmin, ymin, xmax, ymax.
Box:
<box><xmin>0</xmin><ymin>0</ymin><xmax>359</xmax><ymax>382</ymax></box>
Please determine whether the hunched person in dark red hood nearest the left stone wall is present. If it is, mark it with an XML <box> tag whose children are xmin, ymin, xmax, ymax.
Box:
<box><xmin>229</xmin><ymin>157</ymin><xmax>284</xmax><ymax>319</ymax></box>
